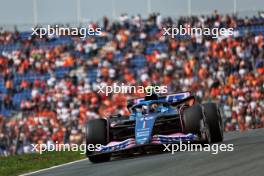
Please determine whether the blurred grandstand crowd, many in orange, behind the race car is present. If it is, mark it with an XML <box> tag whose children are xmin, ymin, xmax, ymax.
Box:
<box><xmin>0</xmin><ymin>12</ymin><xmax>264</xmax><ymax>156</ymax></box>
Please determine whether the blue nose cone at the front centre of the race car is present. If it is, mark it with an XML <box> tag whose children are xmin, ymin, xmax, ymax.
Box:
<box><xmin>135</xmin><ymin>115</ymin><xmax>155</xmax><ymax>144</ymax></box>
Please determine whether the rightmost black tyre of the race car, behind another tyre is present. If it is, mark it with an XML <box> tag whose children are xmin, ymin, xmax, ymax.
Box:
<box><xmin>202</xmin><ymin>103</ymin><xmax>223</xmax><ymax>143</ymax></box>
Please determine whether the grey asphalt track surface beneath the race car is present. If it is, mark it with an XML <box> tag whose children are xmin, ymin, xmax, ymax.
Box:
<box><xmin>27</xmin><ymin>129</ymin><xmax>264</xmax><ymax>176</ymax></box>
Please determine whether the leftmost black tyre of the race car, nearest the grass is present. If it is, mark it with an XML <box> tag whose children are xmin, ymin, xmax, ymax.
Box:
<box><xmin>86</xmin><ymin>119</ymin><xmax>111</xmax><ymax>163</ymax></box>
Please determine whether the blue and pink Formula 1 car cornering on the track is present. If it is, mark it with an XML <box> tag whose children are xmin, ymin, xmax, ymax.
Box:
<box><xmin>86</xmin><ymin>92</ymin><xmax>223</xmax><ymax>163</ymax></box>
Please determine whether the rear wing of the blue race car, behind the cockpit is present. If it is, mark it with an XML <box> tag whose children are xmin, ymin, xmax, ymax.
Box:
<box><xmin>127</xmin><ymin>92</ymin><xmax>195</xmax><ymax>107</ymax></box>
